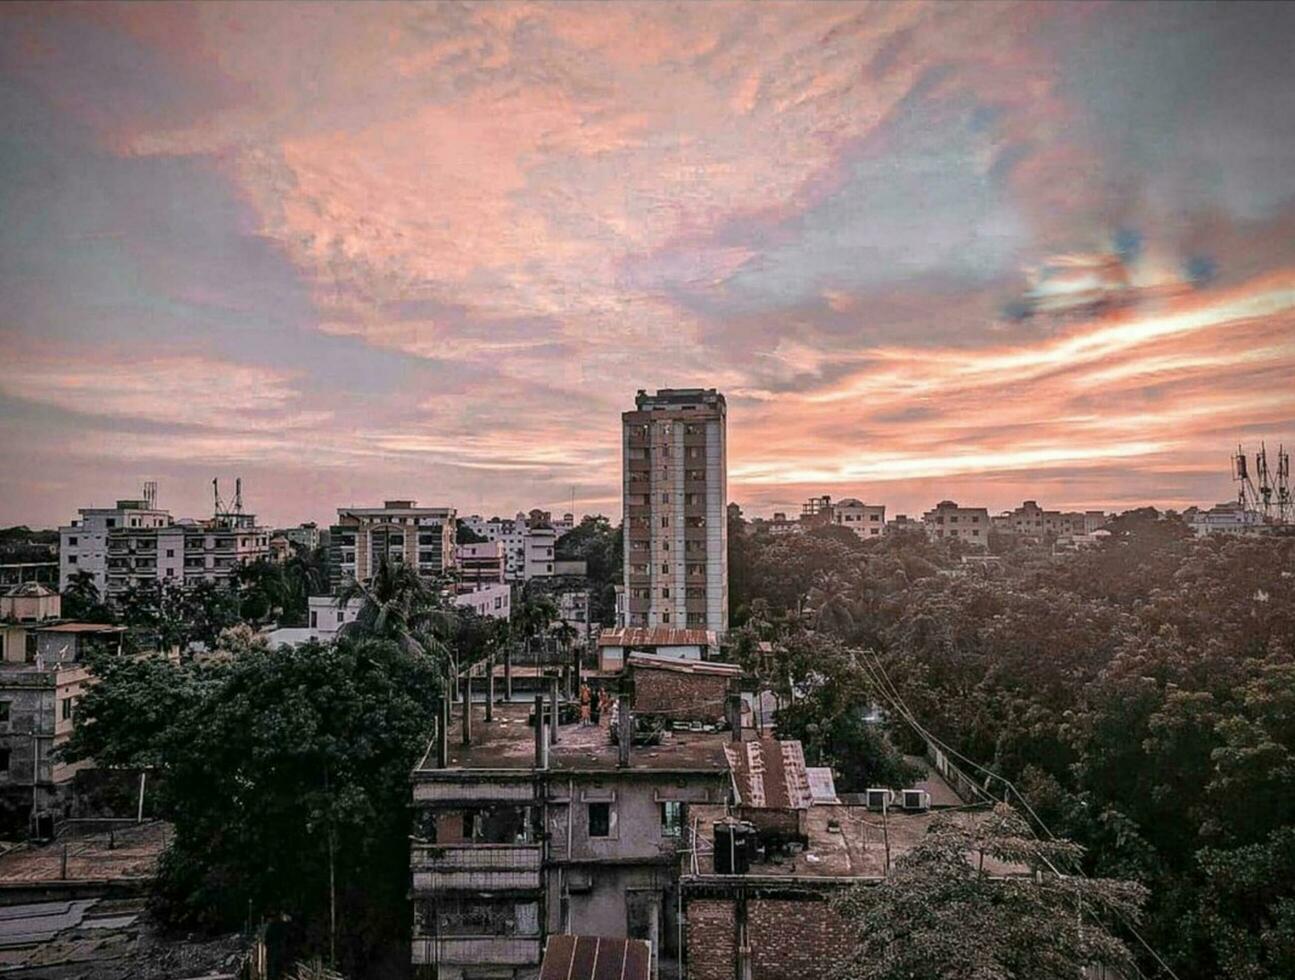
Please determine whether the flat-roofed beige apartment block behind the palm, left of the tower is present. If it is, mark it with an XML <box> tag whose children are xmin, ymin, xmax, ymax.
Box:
<box><xmin>329</xmin><ymin>500</ymin><xmax>456</xmax><ymax>592</ymax></box>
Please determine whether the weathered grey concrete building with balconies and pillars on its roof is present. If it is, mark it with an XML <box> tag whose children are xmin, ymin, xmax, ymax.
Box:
<box><xmin>411</xmin><ymin>652</ymin><xmax>738</xmax><ymax>980</ymax></box>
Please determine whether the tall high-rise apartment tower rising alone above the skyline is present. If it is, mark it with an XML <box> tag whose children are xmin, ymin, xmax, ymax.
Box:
<box><xmin>620</xmin><ymin>388</ymin><xmax>728</xmax><ymax>634</ymax></box>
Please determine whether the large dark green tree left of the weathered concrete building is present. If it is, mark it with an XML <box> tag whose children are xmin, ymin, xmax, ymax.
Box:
<box><xmin>65</xmin><ymin>637</ymin><xmax>442</xmax><ymax>975</ymax></box>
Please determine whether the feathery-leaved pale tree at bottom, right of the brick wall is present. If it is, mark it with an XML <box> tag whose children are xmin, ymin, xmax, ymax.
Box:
<box><xmin>833</xmin><ymin>804</ymin><xmax>1146</xmax><ymax>980</ymax></box>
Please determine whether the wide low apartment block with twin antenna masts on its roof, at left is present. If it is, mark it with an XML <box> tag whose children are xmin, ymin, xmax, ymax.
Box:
<box><xmin>105</xmin><ymin>513</ymin><xmax>269</xmax><ymax>599</ymax></box>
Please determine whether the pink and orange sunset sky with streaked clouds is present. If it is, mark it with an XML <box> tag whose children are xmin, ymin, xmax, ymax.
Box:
<box><xmin>0</xmin><ymin>1</ymin><xmax>1295</xmax><ymax>526</ymax></box>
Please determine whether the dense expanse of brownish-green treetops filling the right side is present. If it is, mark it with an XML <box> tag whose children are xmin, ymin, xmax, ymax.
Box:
<box><xmin>730</xmin><ymin>510</ymin><xmax>1295</xmax><ymax>980</ymax></box>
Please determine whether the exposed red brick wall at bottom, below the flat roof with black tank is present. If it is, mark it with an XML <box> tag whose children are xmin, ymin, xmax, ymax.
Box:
<box><xmin>686</xmin><ymin>898</ymin><xmax>851</xmax><ymax>980</ymax></box>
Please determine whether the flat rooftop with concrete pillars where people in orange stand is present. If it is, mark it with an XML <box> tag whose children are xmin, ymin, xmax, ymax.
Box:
<box><xmin>418</xmin><ymin>702</ymin><xmax>729</xmax><ymax>773</ymax></box>
